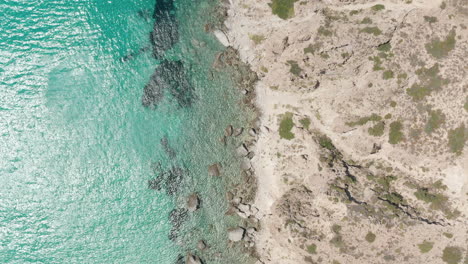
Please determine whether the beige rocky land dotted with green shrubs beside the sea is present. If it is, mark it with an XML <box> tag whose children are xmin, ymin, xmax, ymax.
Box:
<box><xmin>216</xmin><ymin>0</ymin><xmax>468</xmax><ymax>264</ymax></box>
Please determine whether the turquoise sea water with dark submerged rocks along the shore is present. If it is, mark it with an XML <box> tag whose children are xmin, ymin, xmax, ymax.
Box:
<box><xmin>0</xmin><ymin>0</ymin><xmax>253</xmax><ymax>264</ymax></box>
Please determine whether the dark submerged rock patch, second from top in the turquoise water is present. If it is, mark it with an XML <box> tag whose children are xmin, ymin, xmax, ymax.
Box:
<box><xmin>142</xmin><ymin>60</ymin><xmax>195</xmax><ymax>108</ymax></box>
